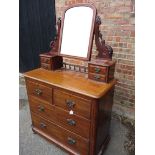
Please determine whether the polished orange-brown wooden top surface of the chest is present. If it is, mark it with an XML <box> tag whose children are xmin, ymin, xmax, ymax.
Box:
<box><xmin>24</xmin><ymin>68</ymin><xmax>116</xmax><ymax>98</ymax></box>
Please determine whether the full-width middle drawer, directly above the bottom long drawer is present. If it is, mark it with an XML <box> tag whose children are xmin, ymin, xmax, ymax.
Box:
<box><xmin>29</xmin><ymin>97</ymin><xmax>90</xmax><ymax>139</ymax></box>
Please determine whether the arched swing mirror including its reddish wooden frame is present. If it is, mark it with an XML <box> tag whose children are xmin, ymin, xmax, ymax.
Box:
<box><xmin>59</xmin><ymin>4</ymin><xmax>96</xmax><ymax>60</ymax></box>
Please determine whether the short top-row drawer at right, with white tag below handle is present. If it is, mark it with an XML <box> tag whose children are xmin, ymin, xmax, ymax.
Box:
<box><xmin>53</xmin><ymin>89</ymin><xmax>91</xmax><ymax>119</ymax></box>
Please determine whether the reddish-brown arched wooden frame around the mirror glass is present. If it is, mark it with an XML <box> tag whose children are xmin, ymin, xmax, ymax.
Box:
<box><xmin>58</xmin><ymin>3</ymin><xmax>97</xmax><ymax>60</ymax></box>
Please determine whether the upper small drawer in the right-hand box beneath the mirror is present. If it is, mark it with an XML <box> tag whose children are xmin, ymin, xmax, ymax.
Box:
<box><xmin>89</xmin><ymin>64</ymin><xmax>108</xmax><ymax>74</ymax></box>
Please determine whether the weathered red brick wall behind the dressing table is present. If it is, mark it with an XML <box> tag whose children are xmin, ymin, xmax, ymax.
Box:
<box><xmin>55</xmin><ymin>0</ymin><xmax>135</xmax><ymax>118</ymax></box>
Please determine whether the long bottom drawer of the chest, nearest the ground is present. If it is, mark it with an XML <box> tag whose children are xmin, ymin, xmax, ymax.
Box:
<box><xmin>31</xmin><ymin>114</ymin><xmax>89</xmax><ymax>155</ymax></box>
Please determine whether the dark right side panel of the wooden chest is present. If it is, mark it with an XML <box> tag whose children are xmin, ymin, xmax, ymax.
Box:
<box><xmin>95</xmin><ymin>89</ymin><xmax>114</xmax><ymax>155</ymax></box>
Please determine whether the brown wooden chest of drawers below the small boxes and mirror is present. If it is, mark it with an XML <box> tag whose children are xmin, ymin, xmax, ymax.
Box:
<box><xmin>25</xmin><ymin>68</ymin><xmax>116</xmax><ymax>155</ymax></box>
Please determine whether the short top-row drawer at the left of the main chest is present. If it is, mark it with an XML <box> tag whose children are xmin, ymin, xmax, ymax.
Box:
<box><xmin>27</xmin><ymin>80</ymin><xmax>52</xmax><ymax>103</ymax></box>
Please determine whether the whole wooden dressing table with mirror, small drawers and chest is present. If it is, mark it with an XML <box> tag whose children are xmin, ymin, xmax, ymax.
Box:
<box><xmin>24</xmin><ymin>4</ymin><xmax>116</xmax><ymax>155</ymax></box>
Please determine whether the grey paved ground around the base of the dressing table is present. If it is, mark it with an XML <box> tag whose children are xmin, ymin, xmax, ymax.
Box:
<box><xmin>19</xmin><ymin>100</ymin><xmax>128</xmax><ymax>155</ymax></box>
